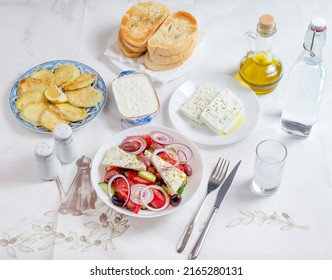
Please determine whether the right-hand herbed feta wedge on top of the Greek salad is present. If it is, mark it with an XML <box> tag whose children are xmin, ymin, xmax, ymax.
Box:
<box><xmin>144</xmin><ymin>150</ymin><xmax>187</xmax><ymax>194</ymax></box>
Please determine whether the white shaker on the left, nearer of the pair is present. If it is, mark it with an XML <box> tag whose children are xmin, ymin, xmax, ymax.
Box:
<box><xmin>34</xmin><ymin>142</ymin><xmax>61</xmax><ymax>180</ymax></box>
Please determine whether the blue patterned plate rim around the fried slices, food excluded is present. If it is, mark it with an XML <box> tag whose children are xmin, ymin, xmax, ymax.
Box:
<box><xmin>9</xmin><ymin>60</ymin><xmax>107</xmax><ymax>134</ymax></box>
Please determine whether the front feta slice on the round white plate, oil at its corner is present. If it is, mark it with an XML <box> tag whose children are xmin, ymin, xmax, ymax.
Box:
<box><xmin>200</xmin><ymin>88</ymin><xmax>244</xmax><ymax>135</ymax></box>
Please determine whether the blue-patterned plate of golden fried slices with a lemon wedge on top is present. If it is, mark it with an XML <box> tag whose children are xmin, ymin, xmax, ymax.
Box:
<box><xmin>9</xmin><ymin>60</ymin><xmax>107</xmax><ymax>133</ymax></box>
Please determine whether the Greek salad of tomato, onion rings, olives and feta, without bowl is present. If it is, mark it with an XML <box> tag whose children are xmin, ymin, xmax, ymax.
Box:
<box><xmin>99</xmin><ymin>131</ymin><xmax>193</xmax><ymax>214</ymax></box>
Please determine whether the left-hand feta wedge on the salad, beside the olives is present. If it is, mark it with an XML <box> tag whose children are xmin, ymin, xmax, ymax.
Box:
<box><xmin>102</xmin><ymin>147</ymin><xmax>146</xmax><ymax>171</ymax></box>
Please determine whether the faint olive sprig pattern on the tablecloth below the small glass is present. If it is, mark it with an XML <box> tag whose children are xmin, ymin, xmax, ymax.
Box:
<box><xmin>226</xmin><ymin>209</ymin><xmax>309</xmax><ymax>231</ymax></box>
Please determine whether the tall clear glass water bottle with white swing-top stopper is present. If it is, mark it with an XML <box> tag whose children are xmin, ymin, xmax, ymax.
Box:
<box><xmin>281</xmin><ymin>17</ymin><xmax>326</xmax><ymax>137</ymax></box>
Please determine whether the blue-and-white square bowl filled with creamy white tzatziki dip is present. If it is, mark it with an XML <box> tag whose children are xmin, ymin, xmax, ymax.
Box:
<box><xmin>112</xmin><ymin>70</ymin><xmax>160</xmax><ymax>125</ymax></box>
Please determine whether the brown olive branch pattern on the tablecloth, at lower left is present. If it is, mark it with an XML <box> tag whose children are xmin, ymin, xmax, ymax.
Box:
<box><xmin>0</xmin><ymin>202</ymin><xmax>130</xmax><ymax>259</ymax></box>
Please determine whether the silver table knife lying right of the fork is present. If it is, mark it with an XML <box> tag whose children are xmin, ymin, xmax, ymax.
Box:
<box><xmin>189</xmin><ymin>161</ymin><xmax>241</xmax><ymax>259</ymax></box>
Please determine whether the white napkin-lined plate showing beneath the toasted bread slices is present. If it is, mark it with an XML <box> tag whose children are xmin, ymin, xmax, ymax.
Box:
<box><xmin>104</xmin><ymin>29</ymin><xmax>204</xmax><ymax>84</ymax></box>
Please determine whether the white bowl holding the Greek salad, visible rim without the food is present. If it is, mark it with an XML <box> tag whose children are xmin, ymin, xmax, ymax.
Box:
<box><xmin>91</xmin><ymin>125</ymin><xmax>203</xmax><ymax>218</ymax></box>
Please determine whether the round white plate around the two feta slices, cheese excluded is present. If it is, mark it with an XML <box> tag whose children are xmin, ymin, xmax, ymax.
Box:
<box><xmin>168</xmin><ymin>73</ymin><xmax>259</xmax><ymax>145</ymax></box>
